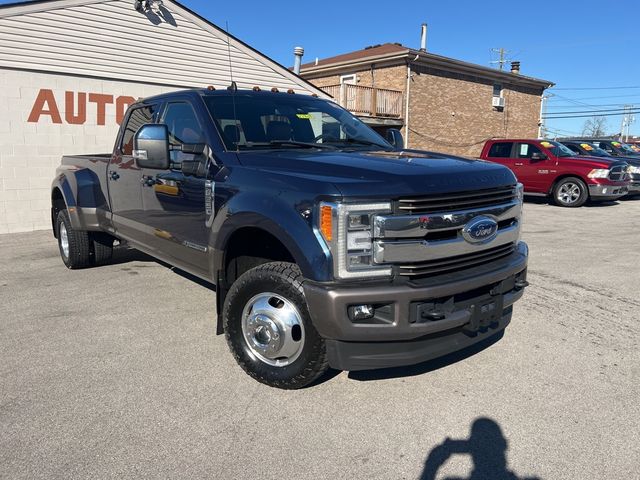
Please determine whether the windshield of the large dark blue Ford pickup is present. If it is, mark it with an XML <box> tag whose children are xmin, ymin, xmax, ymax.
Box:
<box><xmin>203</xmin><ymin>92</ymin><xmax>393</xmax><ymax>150</ymax></box>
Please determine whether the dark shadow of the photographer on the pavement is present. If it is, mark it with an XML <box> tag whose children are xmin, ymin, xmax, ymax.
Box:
<box><xmin>420</xmin><ymin>417</ymin><xmax>540</xmax><ymax>480</ymax></box>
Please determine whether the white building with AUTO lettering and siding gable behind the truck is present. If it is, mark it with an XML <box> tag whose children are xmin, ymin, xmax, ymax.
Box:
<box><xmin>0</xmin><ymin>0</ymin><xmax>326</xmax><ymax>233</ymax></box>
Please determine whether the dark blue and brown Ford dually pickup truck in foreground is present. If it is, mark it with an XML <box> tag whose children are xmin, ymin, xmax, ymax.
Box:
<box><xmin>51</xmin><ymin>89</ymin><xmax>528</xmax><ymax>388</ymax></box>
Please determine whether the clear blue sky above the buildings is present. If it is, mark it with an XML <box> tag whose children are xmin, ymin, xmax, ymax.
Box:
<box><xmin>0</xmin><ymin>0</ymin><xmax>640</xmax><ymax>139</ymax></box>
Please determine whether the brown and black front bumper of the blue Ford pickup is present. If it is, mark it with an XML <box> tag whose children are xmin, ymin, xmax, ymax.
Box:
<box><xmin>304</xmin><ymin>242</ymin><xmax>528</xmax><ymax>370</ymax></box>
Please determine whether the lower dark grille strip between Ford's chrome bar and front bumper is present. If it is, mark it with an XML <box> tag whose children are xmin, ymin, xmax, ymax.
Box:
<box><xmin>398</xmin><ymin>243</ymin><xmax>515</xmax><ymax>278</ymax></box>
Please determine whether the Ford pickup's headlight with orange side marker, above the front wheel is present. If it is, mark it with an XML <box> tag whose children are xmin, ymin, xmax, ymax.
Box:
<box><xmin>318</xmin><ymin>202</ymin><xmax>391</xmax><ymax>279</ymax></box>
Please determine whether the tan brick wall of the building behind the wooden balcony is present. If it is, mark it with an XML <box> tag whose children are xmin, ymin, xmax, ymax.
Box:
<box><xmin>309</xmin><ymin>65</ymin><xmax>542</xmax><ymax>157</ymax></box>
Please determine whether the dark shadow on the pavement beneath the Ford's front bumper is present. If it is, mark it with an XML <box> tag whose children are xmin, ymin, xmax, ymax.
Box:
<box><xmin>349</xmin><ymin>330</ymin><xmax>504</xmax><ymax>381</ymax></box>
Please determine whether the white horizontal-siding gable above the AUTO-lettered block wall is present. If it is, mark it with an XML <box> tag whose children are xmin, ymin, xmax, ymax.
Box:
<box><xmin>0</xmin><ymin>0</ymin><xmax>323</xmax><ymax>95</ymax></box>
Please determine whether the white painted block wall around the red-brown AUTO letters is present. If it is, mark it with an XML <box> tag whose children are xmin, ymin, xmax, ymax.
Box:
<box><xmin>0</xmin><ymin>68</ymin><xmax>175</xmax><ymax>233</ymax></box>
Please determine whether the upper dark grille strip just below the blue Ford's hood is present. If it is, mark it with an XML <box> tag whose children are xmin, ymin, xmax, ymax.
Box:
<box><xmin>397</xmin><ymin>187</ymin><xmax>516</xmax><ymax>213</ymax></box>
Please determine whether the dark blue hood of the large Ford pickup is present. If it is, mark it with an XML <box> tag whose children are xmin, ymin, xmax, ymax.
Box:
<box><xmin>239</xmin><ymin>150</ymin><xmax>516</xmax><ymax>198</ymax></box>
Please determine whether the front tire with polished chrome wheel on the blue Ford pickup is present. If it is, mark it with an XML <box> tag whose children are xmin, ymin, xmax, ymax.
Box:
<box><xmin>222</xmin><ymin>262</ymin><xmax>328</xmax><ymax>389</ymax></box>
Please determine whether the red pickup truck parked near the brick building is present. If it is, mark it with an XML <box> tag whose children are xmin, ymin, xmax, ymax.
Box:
<box><xmin>480</xmin><ymin>139</ymin><xmax>630</xmax><ymax>207</ymax></box>
